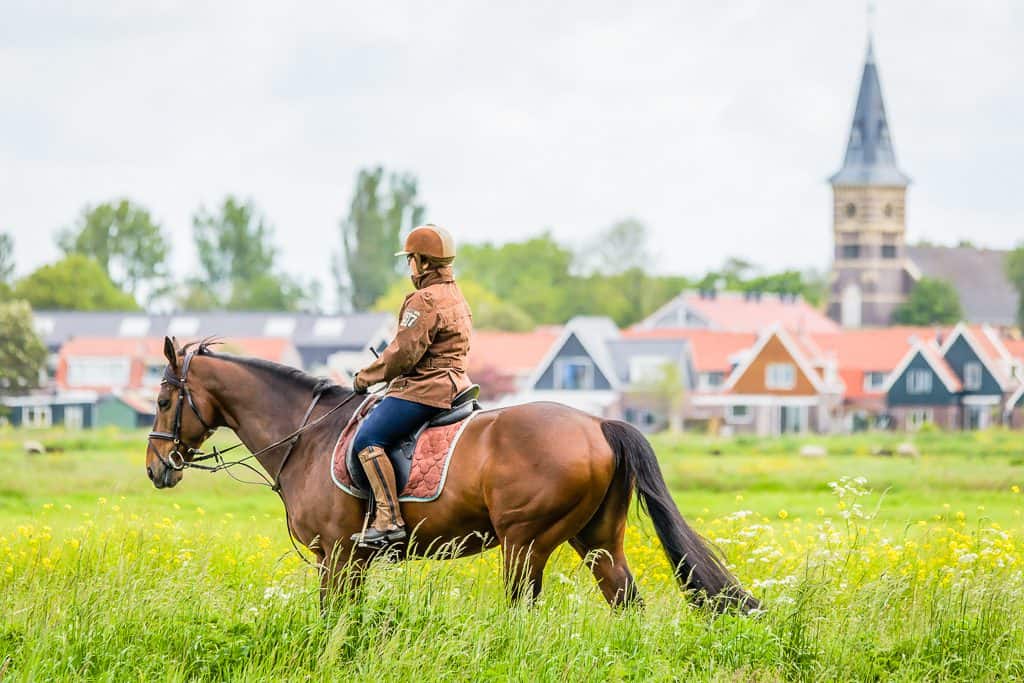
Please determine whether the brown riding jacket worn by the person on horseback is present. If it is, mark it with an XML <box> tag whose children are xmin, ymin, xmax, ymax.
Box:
<box><xmin>359</xmin><ymin>266</ymin><xmax>473</xmax><ymax>409</ymax></box>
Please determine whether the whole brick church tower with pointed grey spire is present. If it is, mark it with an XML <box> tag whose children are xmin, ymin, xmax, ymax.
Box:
<box><xmin>828</xmin><ymin>39</ymin><xmax>910</xmax><ymax>328</ymax></box>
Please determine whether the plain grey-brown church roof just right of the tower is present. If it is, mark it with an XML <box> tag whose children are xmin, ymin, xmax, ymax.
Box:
<box><xmin>906</xmin><ymin>247</ymin><xmax>1018</xmax><ymax>326</ymax></box>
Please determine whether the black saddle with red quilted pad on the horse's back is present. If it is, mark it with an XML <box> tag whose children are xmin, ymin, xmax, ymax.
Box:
<box><xmin>332</xmin><ymin>384</ymin><xmax>481</xmax><ymax>501</ymax></box>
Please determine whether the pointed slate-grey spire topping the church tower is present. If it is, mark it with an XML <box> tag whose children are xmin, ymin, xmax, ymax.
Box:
<box><xmin>829</xmin><ymin>41</ymin><xmax>910</xmax><ymax>187</ymax></box>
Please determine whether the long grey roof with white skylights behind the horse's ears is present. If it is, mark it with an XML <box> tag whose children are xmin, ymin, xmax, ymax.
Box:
<box><xmin>35</xmin><ymin>310</ymin><xmax>394</xmax><ymax>351</ymax></box>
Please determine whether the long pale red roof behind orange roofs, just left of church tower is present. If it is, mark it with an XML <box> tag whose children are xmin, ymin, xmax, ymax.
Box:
<box><xmin>683</xmin><ymin>292</ymin><xmax>840</xmax><ymax>334</ymax></box>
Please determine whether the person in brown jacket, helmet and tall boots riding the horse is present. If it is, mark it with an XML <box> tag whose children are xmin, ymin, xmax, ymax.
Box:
<box><xmin>352</xmin><ymin>223</ymin><xmax>473</xmax><ymax>546</ymax></box>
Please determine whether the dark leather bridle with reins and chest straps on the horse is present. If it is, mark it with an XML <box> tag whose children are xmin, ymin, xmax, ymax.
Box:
<box><xmin>148</xmin><ymin>344</ymin><xmax>359</xmax><ymax>564</ymax></box>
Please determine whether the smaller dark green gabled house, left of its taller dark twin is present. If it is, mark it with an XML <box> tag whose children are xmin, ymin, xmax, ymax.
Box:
<box><xmin>885</xmin><ymin>339</ymin><xmax>964</xmax><ymax>431</ymax></box>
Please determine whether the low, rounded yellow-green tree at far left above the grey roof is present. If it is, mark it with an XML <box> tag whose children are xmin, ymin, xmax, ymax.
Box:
<box><xmin>14</xmin><ymin>254</ymin><xmax>138</xmax><ymax>310</ymax></box>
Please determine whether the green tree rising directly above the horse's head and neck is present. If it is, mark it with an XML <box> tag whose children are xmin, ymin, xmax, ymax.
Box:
<box><xmin>190</xmin><ymin>197</ymin><xmax>305</xmax><ymax>310</ymax></box>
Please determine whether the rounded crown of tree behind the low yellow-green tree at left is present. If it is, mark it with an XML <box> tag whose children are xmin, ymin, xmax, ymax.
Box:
<box><xmin>57</xmin><ymin>199</ymin><xmax>169</xmax><ymax>296</ymax></box>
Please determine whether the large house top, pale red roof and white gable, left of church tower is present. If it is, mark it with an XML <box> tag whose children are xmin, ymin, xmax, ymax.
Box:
<box><xmin>636</xmin><ymin>292</ymin><xmax>840</xmax><ymax>334</ymax></box>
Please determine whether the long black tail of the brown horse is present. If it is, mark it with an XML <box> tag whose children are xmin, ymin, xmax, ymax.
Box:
<box><xmin>601</xmin><ymin>420</ymin><xmax>759</xmax><ymax>611</ymax></box>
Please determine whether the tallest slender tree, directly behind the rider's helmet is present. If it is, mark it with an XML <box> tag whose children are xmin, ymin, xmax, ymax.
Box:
<box><xmin>334</xmin><ymin>166</ymin><xmax>424</xmax><ymax>310</ymax></box>
